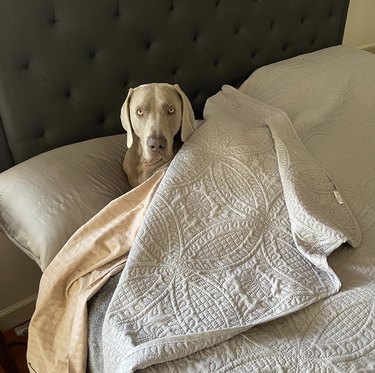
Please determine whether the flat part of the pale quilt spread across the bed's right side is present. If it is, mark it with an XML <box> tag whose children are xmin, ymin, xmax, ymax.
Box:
<box><xmin>144</xmin><ymin>46</ymin><xmax>375</xmax><ymax>373</ymax></box>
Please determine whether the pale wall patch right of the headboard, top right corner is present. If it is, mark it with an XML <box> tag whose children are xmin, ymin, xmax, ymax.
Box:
<box><xmin>343</xmin><ymin>0</ymin><xmax>375</xmax><ymax>48</ymax></box>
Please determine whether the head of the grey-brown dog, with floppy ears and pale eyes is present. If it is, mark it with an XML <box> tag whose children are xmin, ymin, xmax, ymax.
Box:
<box><xmin>121</xmin><ymin>83</ymin><xmax>195</xmax><ymax>163</ymax></box>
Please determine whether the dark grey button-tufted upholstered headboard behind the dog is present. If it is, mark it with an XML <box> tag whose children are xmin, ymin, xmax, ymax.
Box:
<box><xmin>0</xmin><ymin>0</ymin><xmax>349</xmax><ymax>171</ymax></box>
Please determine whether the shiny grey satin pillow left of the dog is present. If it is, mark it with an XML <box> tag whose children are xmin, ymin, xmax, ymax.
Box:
<box><xmin>0</xmin><ymin>134</ymin><xmax>130</xmax><ymax>270</ymax></box>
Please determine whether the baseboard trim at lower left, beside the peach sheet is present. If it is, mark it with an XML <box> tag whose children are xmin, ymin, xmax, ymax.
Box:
<box><xmin>0</xmin><ymin>294</ymin><xmax>37</xmax><ymax>331</ymax></box>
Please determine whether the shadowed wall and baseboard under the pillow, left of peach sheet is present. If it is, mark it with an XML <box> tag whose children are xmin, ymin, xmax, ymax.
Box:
<box><xmin>0</xmin><ymin>233</ymin><xmax>41</xmax><ymax>331</ymax></box>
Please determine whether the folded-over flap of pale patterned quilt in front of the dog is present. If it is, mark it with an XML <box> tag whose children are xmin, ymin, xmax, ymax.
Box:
<box><xmin>102</xmin><ymin>86</ymin><xmax>360</xmax><ymax>373</ymax></box>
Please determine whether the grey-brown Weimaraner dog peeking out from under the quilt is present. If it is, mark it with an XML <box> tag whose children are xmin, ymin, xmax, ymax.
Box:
<box><xmin>120</xmin><ymin>83</ymin><xmax>195</xmax><ymax>188</ymax></box>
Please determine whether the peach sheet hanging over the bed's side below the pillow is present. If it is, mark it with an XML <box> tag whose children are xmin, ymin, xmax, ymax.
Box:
<box><xmin>27</xmin><ymin>170</ymin><xmax>165</xmax><ymax>373</ymax></box>
